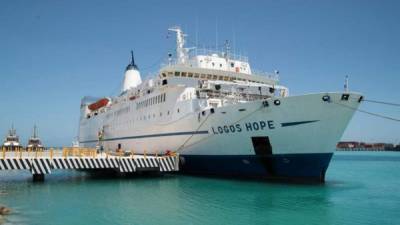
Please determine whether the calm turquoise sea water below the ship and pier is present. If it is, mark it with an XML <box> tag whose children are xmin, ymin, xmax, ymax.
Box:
<box><xmin>0</xmin><ymin>152</ymin><xmax>400</xmax><ymax>225</ymax></box>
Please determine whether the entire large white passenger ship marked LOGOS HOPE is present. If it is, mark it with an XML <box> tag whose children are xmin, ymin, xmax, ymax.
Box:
<box><xmin>78</xmin><ymin>27</ymin><xmax>363</xmax><ymax>182</ymax></box>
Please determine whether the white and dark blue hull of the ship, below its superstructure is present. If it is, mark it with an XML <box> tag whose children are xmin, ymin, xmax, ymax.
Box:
<box><xmin>79</xmin><ymin>93</ymin><xmax>360</xmax><ymax>180</ymax></box>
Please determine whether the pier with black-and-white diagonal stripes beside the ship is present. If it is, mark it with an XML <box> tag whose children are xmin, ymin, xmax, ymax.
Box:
<box><xmin>0</xmin><ymin>148</ymin><xmax>179</xmax><ymax>182</ymax></box>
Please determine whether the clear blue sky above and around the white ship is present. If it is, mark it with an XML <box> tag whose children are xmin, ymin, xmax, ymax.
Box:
<box><xmin>0</xmin><ymin>0</ymin><xmax>400</xmax><ymax>145</ymax></box>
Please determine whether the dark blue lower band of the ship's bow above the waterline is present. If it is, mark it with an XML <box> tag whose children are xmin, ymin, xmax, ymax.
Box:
<box><xmin>180</xmin><ymin>153</ymin><xmax>333</xmax><ymax>182</ymax></box>
